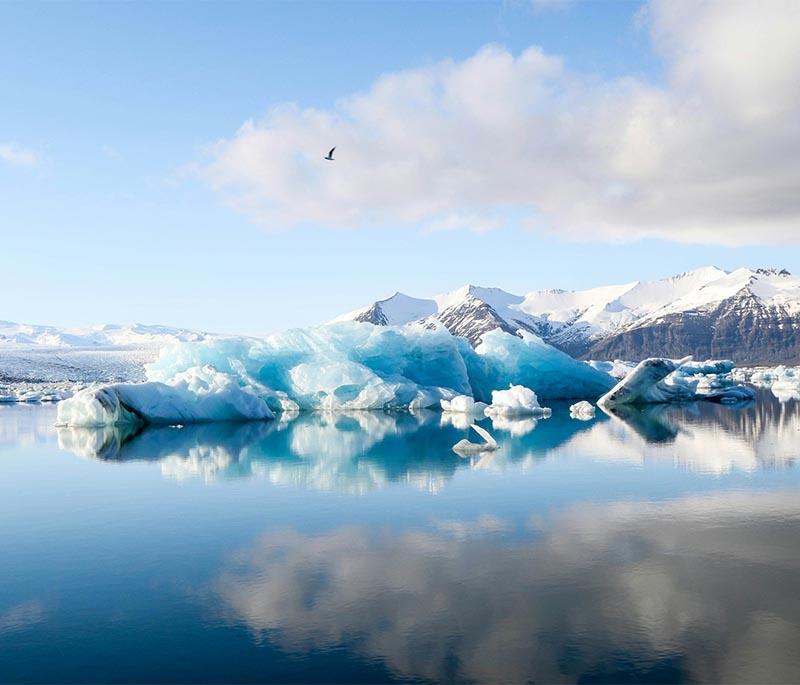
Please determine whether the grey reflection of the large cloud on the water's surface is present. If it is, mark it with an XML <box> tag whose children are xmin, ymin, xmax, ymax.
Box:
<box><xmin>213</xmin><ymin>492</ymin><xmax>800</xmax><ymax>682</ymax></box>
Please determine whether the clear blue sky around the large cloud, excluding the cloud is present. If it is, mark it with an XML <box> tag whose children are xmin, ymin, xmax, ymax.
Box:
<box><xmin>0</xmin><ymin>1</ymin><xmax>800</xmax><ymax>332</ymax></box>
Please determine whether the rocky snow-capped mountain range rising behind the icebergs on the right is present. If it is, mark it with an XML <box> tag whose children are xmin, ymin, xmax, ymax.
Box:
<box><xmin>337</xmin><ymin>266</ymin><xmax>800</xmax><ymax>363</ymax></box>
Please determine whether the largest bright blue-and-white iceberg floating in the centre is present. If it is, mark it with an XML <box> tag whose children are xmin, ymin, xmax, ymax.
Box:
<box><xmin>58</xmin><ymin>322</ymin><xmax>614</xmax><ymax>426</ymax></box>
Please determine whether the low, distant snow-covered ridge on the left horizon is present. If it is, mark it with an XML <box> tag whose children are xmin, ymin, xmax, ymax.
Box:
<box><xmin>0</xmin><ymin>321</ymin><xmax>209</xmax><ymax>348</ymax></box>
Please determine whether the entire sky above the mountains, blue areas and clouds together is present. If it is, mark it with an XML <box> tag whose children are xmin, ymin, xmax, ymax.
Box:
<box><xmin>0</xmin><ymin>0</ymin><xmax>800</xmax><ymax>333</ymax></box>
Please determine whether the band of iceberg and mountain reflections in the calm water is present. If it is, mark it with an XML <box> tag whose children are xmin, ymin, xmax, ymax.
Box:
<box><xmin>58</xmin><ymin>392</ymin><xmax>800</xmax><ymax>493</ymax></box>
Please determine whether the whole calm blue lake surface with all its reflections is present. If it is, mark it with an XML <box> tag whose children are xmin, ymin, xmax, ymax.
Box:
<box><xmin>0</xmin><ymin>394</ymin><xmax>800</xmax><ymax>683</ymax></box>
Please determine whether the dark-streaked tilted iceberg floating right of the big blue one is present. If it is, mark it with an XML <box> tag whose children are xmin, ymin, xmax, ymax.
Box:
<box><xmin>597</xmin><ymin>357</ymin><xmax>755</xmax><ymax>407</ymax></box>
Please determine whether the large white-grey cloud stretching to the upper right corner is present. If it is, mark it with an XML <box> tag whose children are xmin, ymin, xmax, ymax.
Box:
<box><xmin>203</xmin><ymin>0</ymin><xmax>800</xmax><ymax>244</ymax></box>
